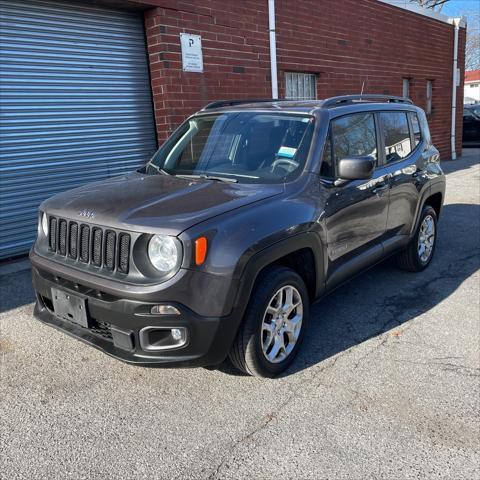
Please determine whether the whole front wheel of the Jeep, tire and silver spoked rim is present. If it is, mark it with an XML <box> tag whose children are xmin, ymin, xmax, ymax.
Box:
<box><xmin>229</xmin><ymin>266</ymin><xmax>309</xmax><ymax>377</ymax></box>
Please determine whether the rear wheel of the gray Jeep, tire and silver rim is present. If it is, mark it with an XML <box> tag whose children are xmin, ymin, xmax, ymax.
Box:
<box><xmin>397</xmin><ymin>205</ymin><xmax>437</xmax><ymax>272</ymax></box>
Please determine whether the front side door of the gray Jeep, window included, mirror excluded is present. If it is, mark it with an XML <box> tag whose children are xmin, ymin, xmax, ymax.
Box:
<box><xmin>325</xmin><ymin>112</ymin><xmax>390</xmax><ymax>288</ymax></box>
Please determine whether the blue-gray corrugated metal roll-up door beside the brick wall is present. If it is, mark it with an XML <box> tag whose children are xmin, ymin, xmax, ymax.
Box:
<box><xmin>0</xmin><ymin>0</ymin><xmax>156</xmax><ymax>258</ymax></box>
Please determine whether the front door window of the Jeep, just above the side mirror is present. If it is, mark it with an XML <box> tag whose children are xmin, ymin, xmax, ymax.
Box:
<box><xmin>332</xmin><ymin>113</ymin><xmax>377</xmax><ymax>167</ymax></box>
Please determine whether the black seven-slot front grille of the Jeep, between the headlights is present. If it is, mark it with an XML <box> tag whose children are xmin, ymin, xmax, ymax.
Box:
<box><xmin>48</xmin><ymin>217</ymin><xmax>131</xmax><ymax>273</ymax></box>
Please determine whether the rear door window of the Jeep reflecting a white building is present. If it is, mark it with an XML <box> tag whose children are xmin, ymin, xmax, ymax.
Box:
<box><xmin>379</xmin><ymin>112</ymin><xmax>412</xmax><ymax>163</ymax></box>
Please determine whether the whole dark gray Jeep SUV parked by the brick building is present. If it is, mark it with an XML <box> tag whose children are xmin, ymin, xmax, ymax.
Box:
<box><xmin>30</xmin><ymin>95</ymin><xmax>445</xmax><ymax>377</ymax></box>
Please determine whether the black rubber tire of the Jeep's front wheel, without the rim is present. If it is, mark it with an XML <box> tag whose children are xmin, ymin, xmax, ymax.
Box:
<box><xmin>229</xmin><ymin>266</ymin><xmax>309</xmax><ymax>378</ymax></box>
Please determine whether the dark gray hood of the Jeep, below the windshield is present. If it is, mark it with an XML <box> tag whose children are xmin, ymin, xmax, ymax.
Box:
<box><xmin>40</xmin><ymin>173</ymin><xmax>284</xmax><ymax>235</ymax></box>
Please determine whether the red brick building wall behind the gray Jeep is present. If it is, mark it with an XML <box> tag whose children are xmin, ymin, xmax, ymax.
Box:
<box><xmin>139</xmin><ymin>0</ymin><xmax>465</xmax><ymax>159</ymax></box>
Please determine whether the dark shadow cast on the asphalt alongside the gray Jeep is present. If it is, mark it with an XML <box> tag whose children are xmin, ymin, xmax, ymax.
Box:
<box><xmin>218</xmin><ymin>204</ymin><xmax>480</xmax><ymax>377</ymax></box>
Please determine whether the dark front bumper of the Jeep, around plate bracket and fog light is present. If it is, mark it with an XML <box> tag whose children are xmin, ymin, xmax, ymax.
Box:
<box><xmin>32</xmin><ymin>265</ymin><xmax>239</xmax><ymax>367</ymax></box>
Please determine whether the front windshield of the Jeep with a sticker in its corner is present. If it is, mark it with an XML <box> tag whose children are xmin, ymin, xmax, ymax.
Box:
<box><xmin>145</xmin><ymin>112</ymin><xmax>313</xmax><ymax>183</ymax></box>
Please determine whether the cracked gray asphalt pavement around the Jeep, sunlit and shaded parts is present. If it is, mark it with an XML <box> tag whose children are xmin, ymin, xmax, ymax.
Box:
<box><xmin>0</xmin><ymin>149</ymin><xmax>480</xmax><ymax>480</ymax></box>
